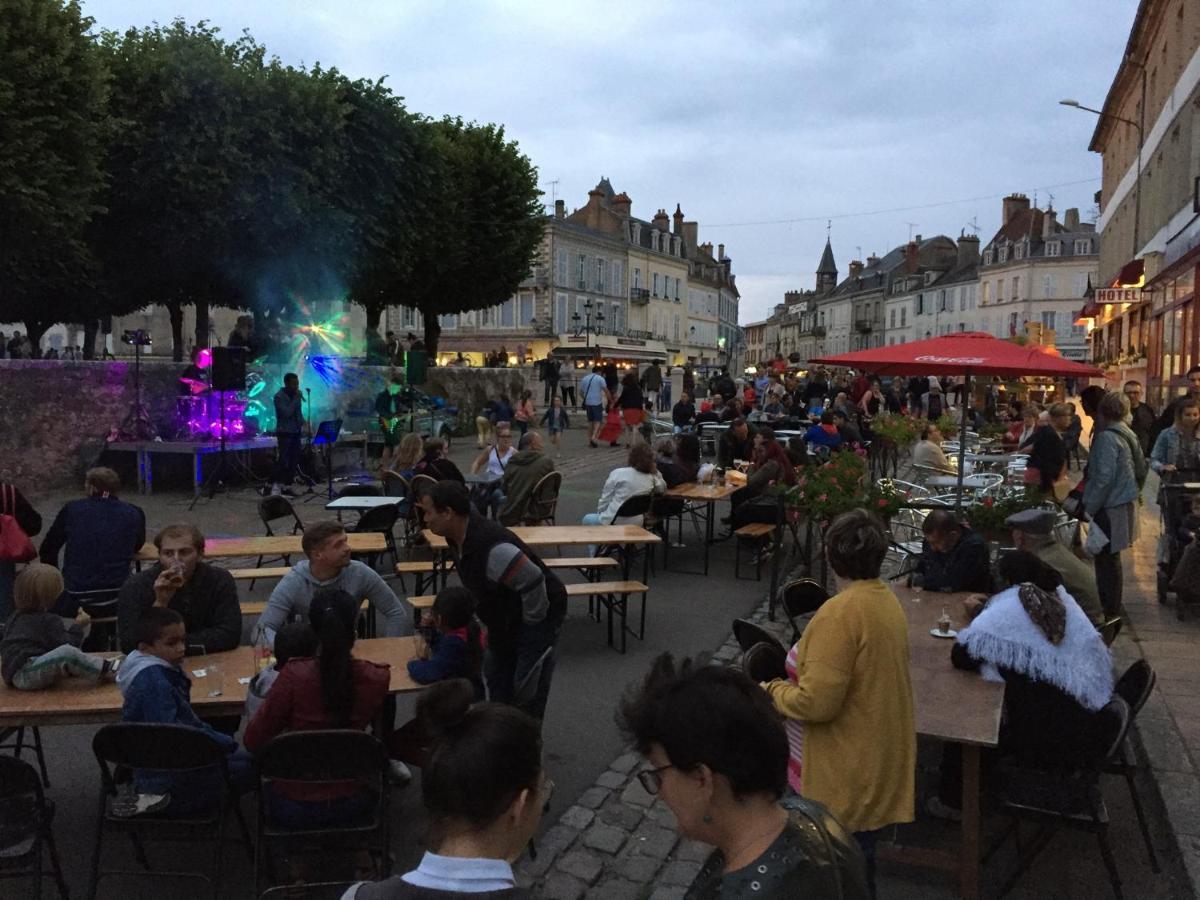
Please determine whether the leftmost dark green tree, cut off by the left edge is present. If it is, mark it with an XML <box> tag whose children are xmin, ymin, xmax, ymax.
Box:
<box><xmin>0</xmin><ymin>0</ymin><xmax>106</xmax><ymax>348</ymax></box>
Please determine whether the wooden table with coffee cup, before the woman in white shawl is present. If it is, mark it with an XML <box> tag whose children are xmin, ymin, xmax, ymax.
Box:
<box><xmin>880</xmin><ymin>586</ymin><xmax>1004</xmax><ymax>900</ymax></box>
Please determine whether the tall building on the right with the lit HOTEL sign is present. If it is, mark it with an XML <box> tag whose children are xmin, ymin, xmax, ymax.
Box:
<box><xmin>1084</xmin><ymin>0</ymin><xmax>1200</xmax><ymax>407</ymax></box>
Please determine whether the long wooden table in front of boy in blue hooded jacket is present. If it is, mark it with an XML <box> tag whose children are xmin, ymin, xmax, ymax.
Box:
<box><xmin>0</xmin><ymin>637</ymin><xmax>421</xmax><ymax>727</ymax></box>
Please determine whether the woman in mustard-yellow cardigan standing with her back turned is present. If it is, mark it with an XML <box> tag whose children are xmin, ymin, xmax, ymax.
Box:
<box><xmin>763</xmin><ymin>510</ymin><xmax>917</xmax><ymax>894</ymax></box>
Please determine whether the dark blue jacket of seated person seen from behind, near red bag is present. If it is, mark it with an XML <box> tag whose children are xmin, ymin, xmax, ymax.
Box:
<box><xmin>38</xmin><ymin>497</ymin><xmax>146</xmax><ymax>590</ymax></box>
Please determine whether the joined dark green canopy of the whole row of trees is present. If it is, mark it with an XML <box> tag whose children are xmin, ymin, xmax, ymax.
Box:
<box><xmin>0</xmin><ymin>0</ymin><xmax>542</xmax><ymax>355</ymax></box>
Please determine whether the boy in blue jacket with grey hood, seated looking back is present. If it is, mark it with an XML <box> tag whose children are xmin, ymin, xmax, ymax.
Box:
<box><xmin>116</xmin><ymin>606</ymin><xmax>253</xmax><ymax>814</ymax></box>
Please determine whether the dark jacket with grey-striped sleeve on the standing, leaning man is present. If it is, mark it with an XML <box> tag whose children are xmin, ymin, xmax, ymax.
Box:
<box><xmin>450</xmin><ymin>510</ymin><xmax>566</xmax><ymax>647</ymax></box>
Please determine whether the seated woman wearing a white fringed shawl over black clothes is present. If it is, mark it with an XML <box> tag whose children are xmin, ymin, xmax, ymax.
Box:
<box><xmin>926</xmin><ymin>551</ymin><xmax>1112</xmax><ymax>818</ymax></box>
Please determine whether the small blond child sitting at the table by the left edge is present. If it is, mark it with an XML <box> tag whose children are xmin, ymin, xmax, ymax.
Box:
<box><xmin>0</xmin><ymin>563</ymin><xmax>115</xmax><ymax>691</ymax></box>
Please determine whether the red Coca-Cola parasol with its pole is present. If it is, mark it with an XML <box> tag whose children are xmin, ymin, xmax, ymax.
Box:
<box><xmin>809</xmin><ymin>331</ymin><xmax>1104</xmax><ymax>505</ymax></box>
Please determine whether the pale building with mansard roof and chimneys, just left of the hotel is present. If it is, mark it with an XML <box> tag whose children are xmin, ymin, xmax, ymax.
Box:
<box><xmin>978</xmin><ymin>193</ymin><xmax>1100</xmax><ymax>361</ymax></box>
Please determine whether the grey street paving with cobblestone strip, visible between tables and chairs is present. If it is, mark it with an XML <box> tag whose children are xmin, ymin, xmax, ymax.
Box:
<box><xmin>7</xmin><ymin>430</ymin><xmax>1200</xmax><ymax>900</ymax></box>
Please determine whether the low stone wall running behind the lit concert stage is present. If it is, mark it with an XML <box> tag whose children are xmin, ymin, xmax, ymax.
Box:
<box><xmin>0</xmin><ymin>360</ymin><xmax>541</xmax><ymax>493</ymax></box>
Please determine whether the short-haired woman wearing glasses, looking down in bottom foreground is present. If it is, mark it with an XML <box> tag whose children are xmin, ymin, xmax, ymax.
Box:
<box><xmin>617</xmin><ymin>654</ymin><xmax>868</xmax><ymax>900</ymax></box>
